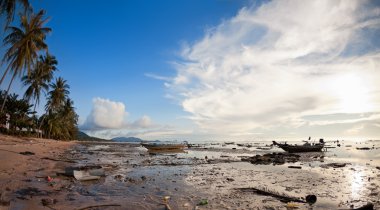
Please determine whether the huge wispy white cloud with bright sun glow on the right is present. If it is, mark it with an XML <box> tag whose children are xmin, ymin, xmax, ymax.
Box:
<box><xmin>166</xmin><ymin>0</ymin><xmax>380</xmax><ymax>138</ymax></box>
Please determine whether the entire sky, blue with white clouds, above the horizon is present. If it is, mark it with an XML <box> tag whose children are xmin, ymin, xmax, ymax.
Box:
<box><xmin>1</xmin><ymin>0</ymin><xmax>380</xmax><ymax>141</ymax></box>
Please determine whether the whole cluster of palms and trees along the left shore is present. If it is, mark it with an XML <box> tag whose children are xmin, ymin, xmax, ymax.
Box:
<box><xmin>0</xmin><ymin>0</ymin><xmax>78</xmax><ymax>140</ymax></box>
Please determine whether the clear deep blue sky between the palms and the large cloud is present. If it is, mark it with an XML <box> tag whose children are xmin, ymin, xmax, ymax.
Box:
<box><xmin>34</xmin><ymin>0</ymin><xmax>249</xmax><ymax>120</ymax></box>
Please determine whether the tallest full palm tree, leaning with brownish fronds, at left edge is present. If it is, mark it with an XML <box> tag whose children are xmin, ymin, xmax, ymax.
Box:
<box><xmin>0</xmin><ymin>10</ymin><xmax>51</xmax><ymax>111</ymax></box>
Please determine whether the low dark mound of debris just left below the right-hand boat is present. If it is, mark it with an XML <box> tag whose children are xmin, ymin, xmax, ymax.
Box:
<box><xmin>241</xmin><ymin>152</ymin><xmax>300</xmax><ymax>165</ymax></box>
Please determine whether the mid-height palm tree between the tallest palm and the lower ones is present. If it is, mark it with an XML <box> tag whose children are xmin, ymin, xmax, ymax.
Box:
<box><xmin>22</xmin><ymin>54</ymin><xmax>58</xmax><ymax>112</ymax></box>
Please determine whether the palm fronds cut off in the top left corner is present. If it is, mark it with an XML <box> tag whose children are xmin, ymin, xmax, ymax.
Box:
<box><xmin>0</xmin><ymin>0</ymin><xmax>31</xmax><ymax>27</ymax></box>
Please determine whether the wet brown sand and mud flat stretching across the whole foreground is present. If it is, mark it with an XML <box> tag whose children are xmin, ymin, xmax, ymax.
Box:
<box><xmin>0</xmin><ymin>136</ymin><xmax>380</xmax><ymax>209</ymax></box>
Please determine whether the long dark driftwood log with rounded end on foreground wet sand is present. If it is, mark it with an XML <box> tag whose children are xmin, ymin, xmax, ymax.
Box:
<box><xmin>236</xmin><ymin>187</ymin><xmax>317</xmax><ymax>204</ymax></box>
